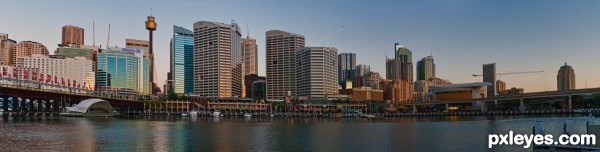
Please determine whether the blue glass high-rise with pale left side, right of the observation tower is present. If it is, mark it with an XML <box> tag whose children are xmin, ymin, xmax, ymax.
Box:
<box><xmin>169</xmin><ymin>25</ymin><xmax>194</xmax><ymax>94</ymax></box>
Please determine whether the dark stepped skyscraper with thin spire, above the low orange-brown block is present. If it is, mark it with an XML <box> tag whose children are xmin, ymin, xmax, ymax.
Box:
<box><xmin>386</xmin><ymin>43</ymin><xmax>413</xmax><ymax>82</ymax></box>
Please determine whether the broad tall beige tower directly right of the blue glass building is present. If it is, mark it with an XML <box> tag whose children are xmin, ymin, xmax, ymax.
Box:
<box><xmin>194</xmin><ymin>21</ymin><xmax>243</xmax><ymax>97</ymax></box>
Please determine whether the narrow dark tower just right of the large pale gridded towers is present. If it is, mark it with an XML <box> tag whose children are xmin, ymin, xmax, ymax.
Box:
<box><xmin>338</xmin><ymin>53</ymin><xmax>356</xmax><ymax>85</ymax></box>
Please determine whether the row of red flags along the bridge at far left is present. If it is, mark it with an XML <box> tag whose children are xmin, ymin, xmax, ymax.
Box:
<box><xmin>0</xmin><ymin>67</ymin><xmax>90</xmax><ymax>89</ymax></box>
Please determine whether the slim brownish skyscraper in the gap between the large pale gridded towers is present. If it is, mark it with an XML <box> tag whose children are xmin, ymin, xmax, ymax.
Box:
<box><xmin>242</xmin><ymin>36</ymin><xmax>258</xmax><ymax>76</ymax></box>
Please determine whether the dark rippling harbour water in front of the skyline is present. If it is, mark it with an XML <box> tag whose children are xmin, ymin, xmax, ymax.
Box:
<box><xmin>0</xmin><ymin>115</ymin><xmax>596</xmax><ymax>152</ymax></box>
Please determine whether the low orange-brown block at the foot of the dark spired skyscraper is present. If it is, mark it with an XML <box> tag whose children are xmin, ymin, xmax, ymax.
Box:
<box><xmin>379</xmin><ymin>79</ymin><xmax>413</xmax><ymax>103</ymax></box>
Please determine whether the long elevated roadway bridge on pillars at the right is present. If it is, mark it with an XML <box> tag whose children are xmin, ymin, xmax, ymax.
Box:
<box><xmin>398</xmin><ymin>88</ymin><xmax>600</xmax><ymax>110</ymax></box>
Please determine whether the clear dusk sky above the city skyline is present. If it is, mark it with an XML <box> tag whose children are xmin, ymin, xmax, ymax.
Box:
<box><xmin>0</xmin><ymin>0</ymin><xmax>600</xmax><ymax>92</ymax></box>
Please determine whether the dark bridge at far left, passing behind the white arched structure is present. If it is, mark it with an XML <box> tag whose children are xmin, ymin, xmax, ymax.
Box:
<box><xmin>0</xmin><ymin>84</ymin><xmax>142</xmax><ymax>113</ymax></box>
